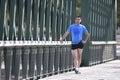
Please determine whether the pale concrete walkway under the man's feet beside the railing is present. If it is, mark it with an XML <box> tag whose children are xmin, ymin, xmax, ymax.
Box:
<box><xmin>40</xmin><ymin>60</ymin><xmax>120</xmax><ymax>80</ymax></box>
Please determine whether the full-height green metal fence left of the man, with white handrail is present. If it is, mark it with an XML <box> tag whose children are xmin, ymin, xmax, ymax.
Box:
<box><xmin>0</xmin><ymin>0</ymin><xmax>76</xmax><ymax>80</ymax></box>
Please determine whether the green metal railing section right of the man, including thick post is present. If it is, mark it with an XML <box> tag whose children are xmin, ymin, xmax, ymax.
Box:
<box><xmin>81</xmin><ymin>0</ymin><xmax>116</xmax><ymax>65</ymax></box>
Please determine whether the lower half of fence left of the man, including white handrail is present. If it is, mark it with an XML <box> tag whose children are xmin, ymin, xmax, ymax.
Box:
<box><xmin>0</xmin><ymin>41</ymin><xmax>73</xmax><ymax>80</ymax></box>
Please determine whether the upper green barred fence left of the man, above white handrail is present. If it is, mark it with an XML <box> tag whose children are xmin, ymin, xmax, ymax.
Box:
<box><xmin>0</xmin><ymin>0</ymin><xmax>76</xmax><ymax>41</ymax></box>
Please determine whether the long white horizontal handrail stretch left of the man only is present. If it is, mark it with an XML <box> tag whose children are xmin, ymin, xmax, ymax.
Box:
<box><xmin>0</xmin><ymin>41</ymin><xmax>71</xmax><ymax>47</ymax></box>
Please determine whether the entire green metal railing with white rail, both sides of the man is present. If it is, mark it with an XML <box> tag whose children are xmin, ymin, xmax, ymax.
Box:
<box><xmin>0</xmin><ymin>0</ymin><xmax>116</xmax><ymax>80</ymax></box>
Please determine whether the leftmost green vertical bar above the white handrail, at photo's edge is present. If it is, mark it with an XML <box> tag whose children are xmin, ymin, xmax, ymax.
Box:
<box><xmin>0</xmin><ymin>0</ymin><xmax>7</xmax><ymax>40</ymax></box>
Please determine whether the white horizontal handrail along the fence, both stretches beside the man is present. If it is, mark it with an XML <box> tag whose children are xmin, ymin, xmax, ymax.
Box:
<box><xmin>0</xmin><ymin>41</ymin><xmax>120</xmax><ymax>47</ymax></box>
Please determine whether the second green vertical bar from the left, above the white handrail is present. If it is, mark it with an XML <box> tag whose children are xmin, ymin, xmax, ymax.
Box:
<box><xmin>9</xmin><ymin>0</ymin><xmax>16</xmax><ymax>40</ymax></box>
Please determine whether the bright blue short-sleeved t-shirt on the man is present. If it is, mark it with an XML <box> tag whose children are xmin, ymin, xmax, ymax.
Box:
<box><xmin>67</xmin><ymin>24</ymin><xmax>88</xmax><ymax>44</ymax></box>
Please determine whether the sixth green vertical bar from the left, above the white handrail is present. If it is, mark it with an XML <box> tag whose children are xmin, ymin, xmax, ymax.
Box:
<box><xmin>40</xmin><ymin>0</ymin><xmax>46</xmax><ymax>40</ymax></box>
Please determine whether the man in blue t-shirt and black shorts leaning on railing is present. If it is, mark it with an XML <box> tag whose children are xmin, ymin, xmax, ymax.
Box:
<box><xmin>60</xmin><ymin>16</ymin><xmax>89</xmax><ymax>74</ymax></box>
